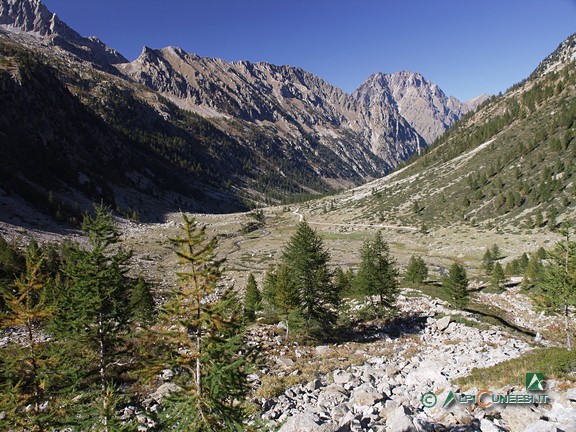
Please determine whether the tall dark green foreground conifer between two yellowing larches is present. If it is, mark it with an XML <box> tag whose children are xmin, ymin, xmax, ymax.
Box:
<box><xmin>52</xmin><ymin>206</ymin><xmax>131</xmax><ymax>432</ymax></box>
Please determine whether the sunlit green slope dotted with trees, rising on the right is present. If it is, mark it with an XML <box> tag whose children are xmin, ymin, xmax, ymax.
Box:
<box><xmin>359</xmin><ymin>35</ymin><xmax>576</xmax><ymax>229</ymax></box>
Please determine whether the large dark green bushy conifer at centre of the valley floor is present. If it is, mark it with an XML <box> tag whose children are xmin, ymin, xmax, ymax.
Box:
<box><xmin>277</xmin><ymin>221</ymin><xmax>339</xmax><ymax>336</ymax></box>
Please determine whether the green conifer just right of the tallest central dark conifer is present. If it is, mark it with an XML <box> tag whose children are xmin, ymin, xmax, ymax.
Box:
<box><xmin>355</xmin><ymin>231</ymin><xmax>398</xmax><ymax>316</ymax></box>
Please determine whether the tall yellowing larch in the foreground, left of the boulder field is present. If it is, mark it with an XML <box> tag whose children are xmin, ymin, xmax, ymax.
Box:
<box><xmin>152</xmin><ymin>216</ymin><xmax>252</xmax><ymax>432</ymax></box>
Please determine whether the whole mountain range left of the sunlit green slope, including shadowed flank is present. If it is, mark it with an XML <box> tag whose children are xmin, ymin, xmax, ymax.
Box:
<box><xmin>0</xmin><ymin>0</ymin><xmax>482</xmax><ymax>221</ymax></box>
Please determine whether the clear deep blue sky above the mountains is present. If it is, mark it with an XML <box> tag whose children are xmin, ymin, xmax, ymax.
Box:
<box><xmin>44</xmin><ymin>0</ymin><xmax>576</xmax><ymax>100</ymax></box>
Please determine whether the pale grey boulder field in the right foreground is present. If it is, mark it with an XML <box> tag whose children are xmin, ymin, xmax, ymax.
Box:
<box><xmin>259</xmin><ymin>296</ymin><xmax>576</xmax><ymax>432</ymax></box>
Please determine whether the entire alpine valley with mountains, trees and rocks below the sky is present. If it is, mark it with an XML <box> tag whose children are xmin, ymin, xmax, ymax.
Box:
<box><xmin>0</xmin><ymin>0</ymin><xmax>576</xmax><ymax>432</ymax></box>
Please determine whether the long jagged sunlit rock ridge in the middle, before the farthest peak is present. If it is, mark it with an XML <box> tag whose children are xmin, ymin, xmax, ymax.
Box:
<box><xmin>118</xmin><ymin>47</ymin><xmax>426</xmax><ymax>173</ymax></box>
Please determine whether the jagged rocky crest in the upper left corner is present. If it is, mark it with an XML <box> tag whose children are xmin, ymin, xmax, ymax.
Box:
<box><xmin>0</xmin><ymin>0</ymin><xmax>128</xmax><ymax>67</ymax></box>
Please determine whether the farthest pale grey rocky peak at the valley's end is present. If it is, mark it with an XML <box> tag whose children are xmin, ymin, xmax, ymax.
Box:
<box><xmin>353</xmin><ymin>71</ymin><xmax>485</xmax><ymax>144</ymax></box>
